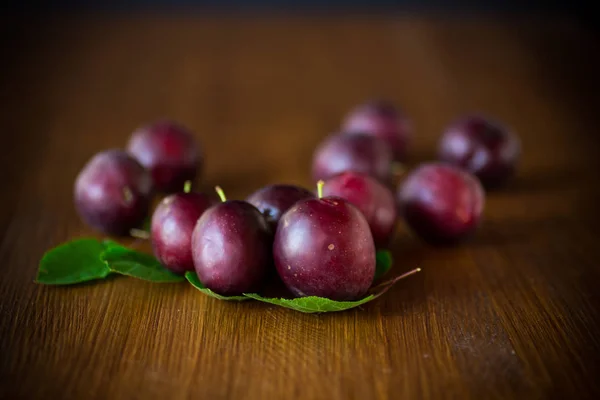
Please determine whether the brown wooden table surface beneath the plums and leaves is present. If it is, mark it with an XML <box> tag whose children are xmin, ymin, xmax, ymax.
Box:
<box><xmin>0</xmin><ymin>14</ymin><xmax>600</xmax><ymax>399</ymax></box>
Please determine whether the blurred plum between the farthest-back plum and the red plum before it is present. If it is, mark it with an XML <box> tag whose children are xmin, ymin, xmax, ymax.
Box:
<box><xmin>312</xmin><ymin>134</ymin><xmax>393</xmax><ymax>184</ymax></box>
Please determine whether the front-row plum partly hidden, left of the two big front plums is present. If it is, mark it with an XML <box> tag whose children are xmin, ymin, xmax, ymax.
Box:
<box><xmin>150</xmin><ymin>193</ymin><xmax>216</xmax><ymax>274</ymax></box>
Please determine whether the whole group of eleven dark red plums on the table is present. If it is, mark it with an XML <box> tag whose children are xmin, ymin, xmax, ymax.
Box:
<box><xmin>75</xmin><ymin>101</ymin><xmax>520</xmax><ymax>300</ymax></box>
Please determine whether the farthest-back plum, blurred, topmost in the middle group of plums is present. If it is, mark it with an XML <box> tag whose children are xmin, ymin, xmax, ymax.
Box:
<box><xmin>342</xmin><ymin>99</ymin><xmax>412</xmax><ymax>162</ymax></box>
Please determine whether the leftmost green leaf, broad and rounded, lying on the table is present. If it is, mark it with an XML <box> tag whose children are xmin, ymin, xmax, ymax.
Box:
<box><xmin>35</xmin><ymin>239</ymin><xmax>110</xmax><ymax>285</ymax></box>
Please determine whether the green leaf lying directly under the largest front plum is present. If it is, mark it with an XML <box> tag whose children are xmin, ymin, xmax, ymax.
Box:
<box><xmin>244</xmin><ymin>293</ymin><xmax>377</xmax><ymax>313</ymax></box>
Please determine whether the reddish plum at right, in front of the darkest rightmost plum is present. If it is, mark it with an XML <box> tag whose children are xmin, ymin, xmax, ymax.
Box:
<box><xmin>397</xmin><ymin>162</ymin><xmax>485</xmax><ymax>244</ymax></box>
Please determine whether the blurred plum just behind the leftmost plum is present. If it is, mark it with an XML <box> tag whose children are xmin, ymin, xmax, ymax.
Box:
<box><xmin>127</xmin><ymin>120</ymin><xmax>203</xmax><ymax>193</ymax></box>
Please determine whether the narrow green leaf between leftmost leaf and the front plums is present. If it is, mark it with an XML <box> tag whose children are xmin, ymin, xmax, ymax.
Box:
<box><xmin>100</xmin><ymin>241</ymin><xmax>184</xmax><ymax>283</ymax></box>
